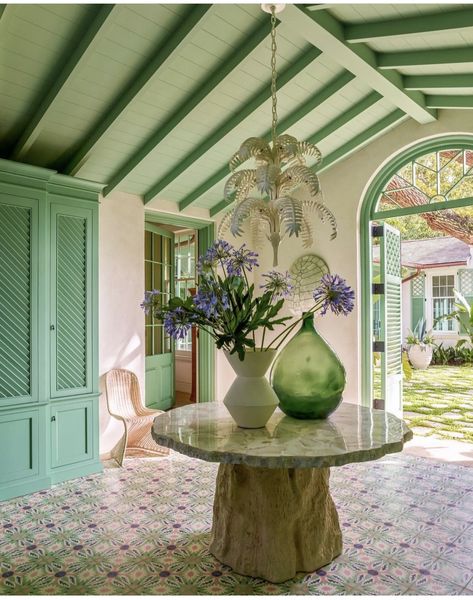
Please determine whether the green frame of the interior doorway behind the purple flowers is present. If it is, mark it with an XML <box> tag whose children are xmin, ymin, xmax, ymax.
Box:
<box><xmin>145</xmin><ymin>210</ymin><xmax>215</xmax><ymax>402</ymax></box>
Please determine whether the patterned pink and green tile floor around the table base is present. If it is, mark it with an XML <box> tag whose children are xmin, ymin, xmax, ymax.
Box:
<box><xmin>0</xmin><ymin>454</ymin><xmax>473</xmax><ymax>595</ymax></box>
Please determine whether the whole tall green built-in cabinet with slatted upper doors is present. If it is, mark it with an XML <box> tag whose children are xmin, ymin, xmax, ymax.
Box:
<box><xmin>0</xmin><ymin>160</ymin><xmax>101</xmax><ymax>500</ymax></box>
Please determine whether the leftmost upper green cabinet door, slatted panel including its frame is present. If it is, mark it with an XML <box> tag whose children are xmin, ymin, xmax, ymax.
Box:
<box><xmin>0</xmin><ymin>195</ymin><xmax>38</xmax><ymax>408</ymax></box>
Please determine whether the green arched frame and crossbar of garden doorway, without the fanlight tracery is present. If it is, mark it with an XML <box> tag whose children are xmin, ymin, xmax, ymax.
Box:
<box><xmin>360</xmin><ymin>134</ymin><xmax>473</xmax><ymax>406</ymax></box>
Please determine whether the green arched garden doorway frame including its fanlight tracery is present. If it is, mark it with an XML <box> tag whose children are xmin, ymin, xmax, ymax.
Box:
<box><xmin>360</xmin><ymin>134</ymin><xmax>473</xmax><ymax>406</ymax></box>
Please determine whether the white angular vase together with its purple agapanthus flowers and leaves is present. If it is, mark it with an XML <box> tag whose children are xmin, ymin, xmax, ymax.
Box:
<box><xmin>141</xmin><ymin>240</ymin><xmax>354</xmax><ymax>428</ymax></box>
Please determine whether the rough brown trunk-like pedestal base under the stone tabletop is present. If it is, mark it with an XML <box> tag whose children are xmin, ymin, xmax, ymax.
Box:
<box><xmin>210</xmin><ymin>464</ymin><xmax>342</xmax><ymax>583</ymax></box>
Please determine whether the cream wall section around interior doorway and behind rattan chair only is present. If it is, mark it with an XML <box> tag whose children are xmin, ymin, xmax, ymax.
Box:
<box><xmin>99</xmin><ymin>192</ymin><xmax>245</xmax><ymax>454</ymax></box>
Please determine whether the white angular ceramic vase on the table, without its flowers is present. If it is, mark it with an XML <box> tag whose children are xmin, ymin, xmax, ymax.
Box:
<box><xmin>223</xmin><ymin>350</ymin><xmax>279</xmax><ymax>429</ymax></box>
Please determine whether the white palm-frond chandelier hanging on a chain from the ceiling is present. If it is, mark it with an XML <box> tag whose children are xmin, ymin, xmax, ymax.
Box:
<box><xmin>219</xmin><ymin>4</ymin><xmax>337</xmax><ymax>266</ymax></box>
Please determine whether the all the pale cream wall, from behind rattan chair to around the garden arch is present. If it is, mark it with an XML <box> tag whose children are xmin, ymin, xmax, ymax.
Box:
<box><xmin>100</xmin><ymin>110</ymin><xmax>473</xmax><ymax>452</ymax></box>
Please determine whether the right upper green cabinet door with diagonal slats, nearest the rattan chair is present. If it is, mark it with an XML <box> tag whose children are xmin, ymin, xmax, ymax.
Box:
<box><xmin>49</xmin><ymin>203</ymin><xmax>93</xmax><ymax>398</ymax></box>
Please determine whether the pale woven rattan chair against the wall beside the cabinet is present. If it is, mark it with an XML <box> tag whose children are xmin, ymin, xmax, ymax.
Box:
<box><xmin>105</xmin><ymin>369</ymin><xmax>169</xmax><ymax>466</ymax></box>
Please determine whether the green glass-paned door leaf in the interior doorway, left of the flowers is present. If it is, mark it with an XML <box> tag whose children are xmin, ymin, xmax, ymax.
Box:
<box><xmin>145</xmin><ymin>223</ymin><xmax>174</xmax><ymax>410</ymax></box>
